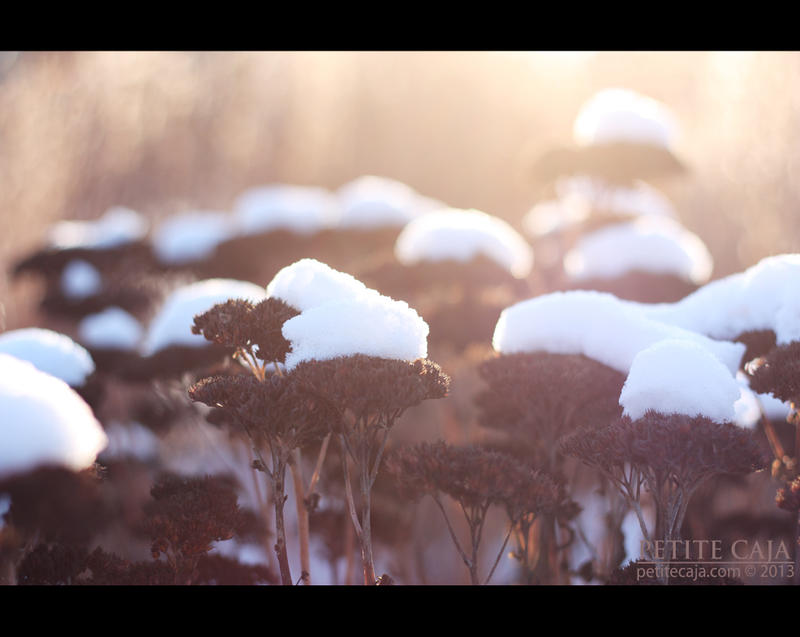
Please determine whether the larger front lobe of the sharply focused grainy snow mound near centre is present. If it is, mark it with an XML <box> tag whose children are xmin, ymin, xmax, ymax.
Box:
<box><xmin>282</xmin><ymin>294</ymin><xmax>428</xmax><ymax>371</ymax></box>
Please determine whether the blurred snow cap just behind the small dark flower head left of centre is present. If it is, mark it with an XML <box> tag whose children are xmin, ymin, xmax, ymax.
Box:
<box><xmin>142</xmin><ymin>279</ymin><xmax>266</xmax><ymax>356</ymax></box>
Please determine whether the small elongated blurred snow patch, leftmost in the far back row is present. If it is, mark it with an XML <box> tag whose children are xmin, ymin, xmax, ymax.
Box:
<box><xmin>48</xmin><ymin>206</ymin><xmax>149</xmax><ymax>250</ymax></box>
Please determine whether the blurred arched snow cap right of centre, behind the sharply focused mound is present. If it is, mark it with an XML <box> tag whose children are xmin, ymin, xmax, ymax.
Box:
<box><xmin>394</xmin><ymin>208</ymin><xmax>533</xmax><ymax>278</ymax></box>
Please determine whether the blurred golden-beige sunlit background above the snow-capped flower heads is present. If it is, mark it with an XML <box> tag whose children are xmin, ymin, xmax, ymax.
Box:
<box><xmin>0</xmin><ymin>51</ymin><xmax>800</xmax><ymax>329</ymax></box>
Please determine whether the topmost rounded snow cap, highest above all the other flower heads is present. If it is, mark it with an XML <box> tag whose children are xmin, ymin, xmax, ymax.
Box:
<box><xmin>573</xmin><ymin>88</ymin><xmax>677</xmax><ymax>148</ymax></box>
